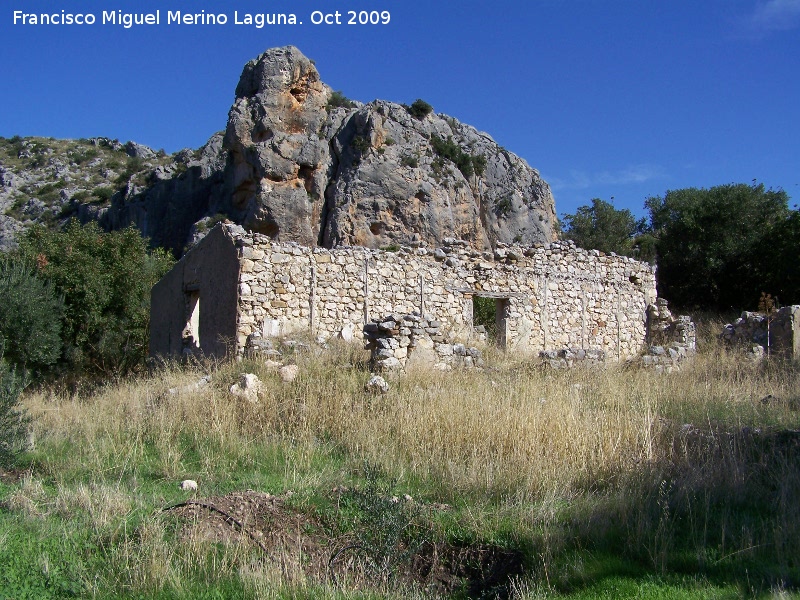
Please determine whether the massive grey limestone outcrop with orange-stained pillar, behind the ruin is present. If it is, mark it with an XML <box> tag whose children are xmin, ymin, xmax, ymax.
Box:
<box><xmin>225</xmin><ymin>46</ymin><xmax>555</xmax><ymax>249</ymax></box>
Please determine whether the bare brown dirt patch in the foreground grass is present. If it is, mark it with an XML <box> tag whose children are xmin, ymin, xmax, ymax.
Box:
<box><xmin>163</xmin><ymin>490</ymin><xmax>524</xmax><ymax>598</ymax></box>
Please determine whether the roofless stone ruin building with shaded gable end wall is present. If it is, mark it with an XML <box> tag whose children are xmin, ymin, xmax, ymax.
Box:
<box><xmin>150</xmin><ymin>223</ymin><xmax>693</xmax><ymax>363</ymax></box>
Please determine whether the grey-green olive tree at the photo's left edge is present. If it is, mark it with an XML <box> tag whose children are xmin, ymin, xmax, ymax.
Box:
<box><xmin>0</xmin><ymin>256</ymin><xmax>63</xmax><ymax>376</ymax></box>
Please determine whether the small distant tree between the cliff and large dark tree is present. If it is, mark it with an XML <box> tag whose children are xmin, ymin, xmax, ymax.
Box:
<box><xmin>561</xmin><ymin>198</ymin><xmax>653</xmax><ymax>260</ymax></box>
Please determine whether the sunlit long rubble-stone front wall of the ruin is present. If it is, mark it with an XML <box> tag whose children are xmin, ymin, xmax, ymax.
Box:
<box><xmin>230</xmin><ymin>225</ymin><xmax>656</xmax><ymax>361</ymax></box>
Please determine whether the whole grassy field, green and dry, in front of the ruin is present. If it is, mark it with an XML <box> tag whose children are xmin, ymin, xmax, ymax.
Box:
<box><xmin>0</xmin><ymin>326</ymin><xmax>800</xmax><ymax>599</ymax></box>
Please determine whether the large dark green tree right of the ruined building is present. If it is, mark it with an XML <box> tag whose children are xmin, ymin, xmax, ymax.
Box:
<box><xmin>645</xmin><ymin>182</ymin><xmax>797</xmax><ymax>310</ymax></box>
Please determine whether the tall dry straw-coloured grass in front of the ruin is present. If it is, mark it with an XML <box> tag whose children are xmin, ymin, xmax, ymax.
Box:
<box><xmin>10</xmin><ymin>330</ymin><xmax>800</xmax><ymax>597</ymax></box>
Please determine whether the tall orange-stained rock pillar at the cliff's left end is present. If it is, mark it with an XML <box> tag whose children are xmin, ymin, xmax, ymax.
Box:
<box><xmin>225</xmin><ymin>46</ymin><xmax>330</xmax><ymax>245</ymax></box>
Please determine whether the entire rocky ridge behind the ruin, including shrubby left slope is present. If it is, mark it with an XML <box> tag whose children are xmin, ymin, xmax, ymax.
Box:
<box><xmin>0</xmin><ymin>46</ymin><xmax>556</xmax><ymax>253</ymax></box>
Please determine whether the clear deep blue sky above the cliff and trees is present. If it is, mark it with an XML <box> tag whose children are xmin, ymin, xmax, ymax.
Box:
<box><xmin>0</xmin><ymin>0</ymin><xmax>800</xmax><ymax>220</ymax></box>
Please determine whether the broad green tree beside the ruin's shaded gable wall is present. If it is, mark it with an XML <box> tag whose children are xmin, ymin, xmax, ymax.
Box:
<box><xmin>20</xmin><ymin>220</ymin><xmax>173</xmax><ymax>376</ymax></box>
